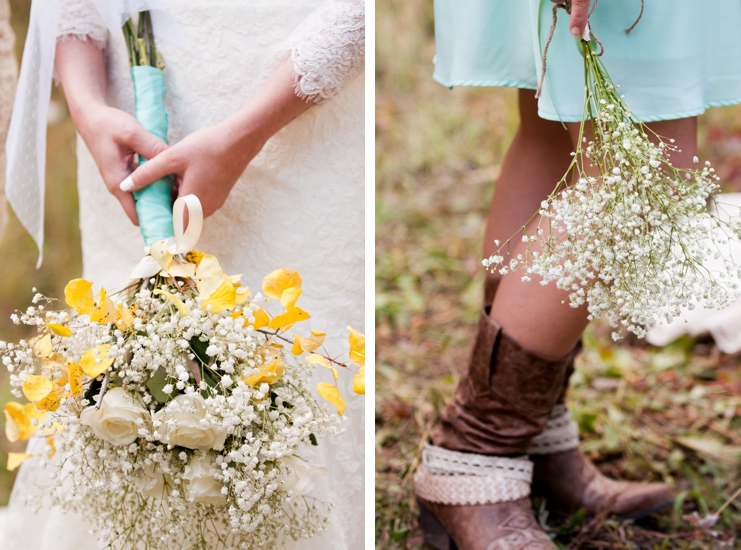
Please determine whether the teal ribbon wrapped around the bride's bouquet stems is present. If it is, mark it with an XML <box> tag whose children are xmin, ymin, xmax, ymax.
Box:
<box><xmin>131</xmin><ymin>66</ymin><xmax>175</xmax><ymax>246</ymax></box>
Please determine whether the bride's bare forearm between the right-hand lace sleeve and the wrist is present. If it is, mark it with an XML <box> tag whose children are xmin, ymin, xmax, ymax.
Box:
<box><xmin>223</xmin><ymin>59</ymin><xmax>314</xmax><ymax>155</ymax></box>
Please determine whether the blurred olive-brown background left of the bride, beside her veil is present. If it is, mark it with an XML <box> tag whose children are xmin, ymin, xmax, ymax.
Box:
<box><xmin>0</xmin><ymin>0</ymin><xmax>82</xmax><ymax>505</ymax></box>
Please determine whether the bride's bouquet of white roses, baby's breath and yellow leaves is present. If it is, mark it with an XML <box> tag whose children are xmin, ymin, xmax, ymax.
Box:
<box><xmin>0</xmin><ymin>250</ymin><xmax>365</xmax><ymax>549</ymax></box>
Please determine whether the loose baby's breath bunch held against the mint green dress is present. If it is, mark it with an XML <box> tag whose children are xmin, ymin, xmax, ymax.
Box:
<box><xmin>483</xmin><ymin>35</ymin><xmax>741</xmax><ymax>339</ymax></box>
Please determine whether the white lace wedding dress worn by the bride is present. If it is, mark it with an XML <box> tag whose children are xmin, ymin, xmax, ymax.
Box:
<box><xmin>0</xmin><ymin>0</ymin><xmax>365</xmax><ymax>550</ymax></box>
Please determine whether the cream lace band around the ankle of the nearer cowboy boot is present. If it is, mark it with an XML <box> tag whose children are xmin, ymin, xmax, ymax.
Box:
<box><xmin>413</xmin><ymin>444</ymin><xmax>533</xmax><ymax>506</ymax></box>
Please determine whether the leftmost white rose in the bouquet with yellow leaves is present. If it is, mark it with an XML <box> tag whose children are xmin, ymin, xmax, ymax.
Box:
<box><xmin>80</xmin><ymin>388</ymin><xmax>149</xmax><ymax>445</ymax></box>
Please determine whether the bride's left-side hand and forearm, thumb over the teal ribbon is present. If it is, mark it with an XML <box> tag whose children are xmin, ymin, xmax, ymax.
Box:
<box><xmin>56</xmin><ymin>37</ymin><xmax>167</xmax><ymax>225</ymax></box>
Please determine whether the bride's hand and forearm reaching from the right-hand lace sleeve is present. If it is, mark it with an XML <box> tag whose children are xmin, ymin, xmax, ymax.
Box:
<box><xmin>121</xmin><ymin>60</ymin><xmax>313</xmax><ymax>216</ymax></box>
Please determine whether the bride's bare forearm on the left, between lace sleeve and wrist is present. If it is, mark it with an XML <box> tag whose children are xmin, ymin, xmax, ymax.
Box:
<box><xmin>55</xmin><ymin>36</ymin><xmax>107</xmax><ymax>138</ymax></box>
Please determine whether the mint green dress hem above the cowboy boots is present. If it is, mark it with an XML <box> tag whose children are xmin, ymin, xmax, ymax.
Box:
<box><xmin>434</xmin><ymin>0</ymin><xmax>741</xmax><ymax>122</ymax></box>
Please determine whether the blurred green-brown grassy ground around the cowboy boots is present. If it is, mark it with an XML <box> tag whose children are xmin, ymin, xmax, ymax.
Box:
<box><xmin>375</xmin><ymin>0</ymin><xmax>741</xmax><ymax>550</ymax></box>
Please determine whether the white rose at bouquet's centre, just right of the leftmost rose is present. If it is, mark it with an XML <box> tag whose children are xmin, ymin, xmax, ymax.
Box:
<box><xmin>154</xmin><ymin>393</ymin><xmax>226</xmax><ymax>451</ymax></box>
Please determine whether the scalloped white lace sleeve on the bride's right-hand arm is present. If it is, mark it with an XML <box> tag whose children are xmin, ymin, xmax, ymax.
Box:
<box><xmin>289</xmin><ymin>0</ymin><xmax>365</xmax><ymax>103</ymax></box>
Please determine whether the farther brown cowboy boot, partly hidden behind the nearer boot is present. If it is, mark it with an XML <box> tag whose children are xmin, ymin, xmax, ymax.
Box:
<box><xmin>484</xmin><ymin>276</ymin><xmax>673</xmax><ymax>519</ymax></box>
